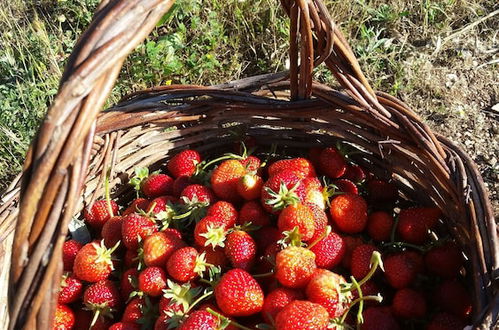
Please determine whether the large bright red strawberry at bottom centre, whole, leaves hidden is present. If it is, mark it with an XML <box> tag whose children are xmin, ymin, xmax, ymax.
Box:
<box><xmin>215</xmin><ymin>269</ymin><xmax>263</xmax><ymax>316</ymax></box>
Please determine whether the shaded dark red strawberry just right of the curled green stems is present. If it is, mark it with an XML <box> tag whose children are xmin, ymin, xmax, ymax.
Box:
<box><xmin>384</xmin><ymin>252</ymin><xmax>418</xmax><ymax>289</ymax></box>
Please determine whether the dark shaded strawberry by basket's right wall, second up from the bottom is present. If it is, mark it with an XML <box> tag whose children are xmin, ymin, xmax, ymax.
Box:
<box><xmin>424</xmin><ymin>242</ymin><xmax>463</xmax><ymax>278</ymax></box>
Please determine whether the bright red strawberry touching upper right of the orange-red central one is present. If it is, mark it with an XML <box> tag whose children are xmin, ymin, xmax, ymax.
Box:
<box><xmin>310</xmin><ymin>233</ymin><xmax>346</xmax><ymax>269</ymax></box>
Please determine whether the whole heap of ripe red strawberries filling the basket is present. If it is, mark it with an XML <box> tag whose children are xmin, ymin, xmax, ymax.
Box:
<box><xmin>54</xmin><ymin>142</ymin><xmax>471</xmax><ymax>330</ymax></box>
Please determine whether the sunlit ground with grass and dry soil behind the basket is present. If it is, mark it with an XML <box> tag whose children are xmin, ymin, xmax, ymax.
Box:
<box><xmin>0</xmin><ymin>0</ymin><xmax>499</xmax><ymax>210</ymax></box>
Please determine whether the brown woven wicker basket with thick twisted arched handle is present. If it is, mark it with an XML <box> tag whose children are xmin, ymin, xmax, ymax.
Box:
<box><xmin>0</xmin><ymin>0</ymin><xmax>499</xmax><ymax>329</ymax></box>
